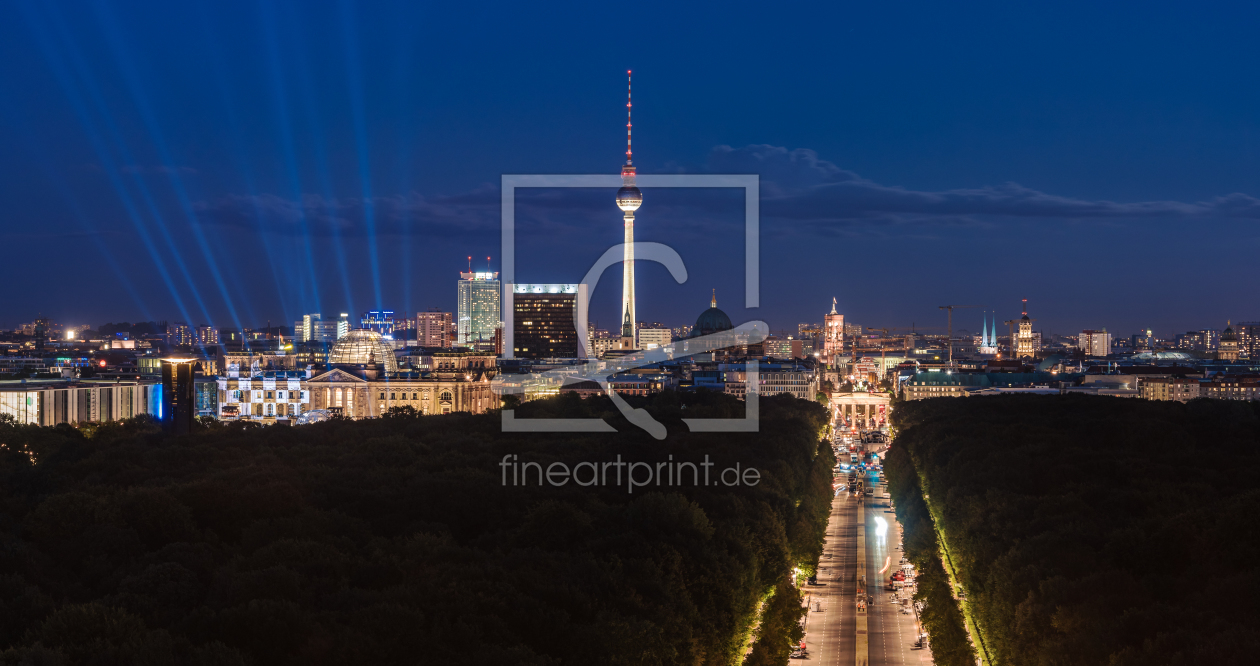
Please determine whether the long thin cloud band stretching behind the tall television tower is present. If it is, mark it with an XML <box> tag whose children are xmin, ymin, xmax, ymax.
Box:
<box><xmin>194</xmin><ymin>145</ymin><xmax>1260</xmax><ymax>237</ymax></box>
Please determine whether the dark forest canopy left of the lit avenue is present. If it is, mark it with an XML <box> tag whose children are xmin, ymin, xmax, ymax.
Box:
<box><xmin>0</xmin><ymin>393</ymin><xmax>833</xmax><ymax>666</ymax></box>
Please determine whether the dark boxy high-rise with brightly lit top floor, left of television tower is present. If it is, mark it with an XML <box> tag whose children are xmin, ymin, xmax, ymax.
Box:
<box><xmin>512</xmin><ymin>285</ymin><xmax>584</xmax><ymax>359</ymax></box>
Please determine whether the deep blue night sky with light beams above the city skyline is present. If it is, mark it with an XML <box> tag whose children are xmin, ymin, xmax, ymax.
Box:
<box><xmin>0</xmin><ymin>0</ymin><xmax>1260</xmax><ymax>335</ymax></box>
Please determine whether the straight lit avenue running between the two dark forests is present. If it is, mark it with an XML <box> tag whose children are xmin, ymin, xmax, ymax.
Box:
<box><xmin>791</xmin><ymin>445</ymin><xmax>932</xmax><ymax>666</ymax></box>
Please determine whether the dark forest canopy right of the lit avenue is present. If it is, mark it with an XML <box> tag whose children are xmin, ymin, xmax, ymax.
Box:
<box><xmin>888</xmin><ymin>395</ymin><xmax>1260</xmax><ymax>666</ymax></box>
